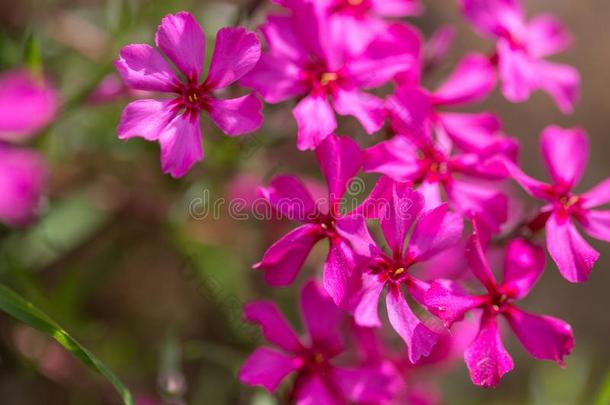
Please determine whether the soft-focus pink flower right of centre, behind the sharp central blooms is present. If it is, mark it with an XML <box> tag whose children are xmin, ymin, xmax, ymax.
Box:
<box><xmin>363</xmin><ymin>88</ymin><xmax>517</xmax><ymax>232</ymax></box>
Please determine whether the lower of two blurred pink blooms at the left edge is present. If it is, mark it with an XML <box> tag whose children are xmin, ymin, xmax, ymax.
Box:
<box><xmin>0</xmin><ymin>144</ymin><xmax>47</xmax><ymax>226</ymax></box>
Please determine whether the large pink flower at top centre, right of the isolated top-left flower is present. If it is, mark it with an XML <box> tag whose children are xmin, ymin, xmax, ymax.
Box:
<box><xmin>241</xmin><ymin>2</ymin><xmax>421</xmax><ymax>150</ymax></box>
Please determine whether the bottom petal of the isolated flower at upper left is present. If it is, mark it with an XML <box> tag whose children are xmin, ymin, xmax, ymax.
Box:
<box><xmin>159</xmin><ymin>114</ymin><xmax>203</xmax><ymax>178</ymax></box>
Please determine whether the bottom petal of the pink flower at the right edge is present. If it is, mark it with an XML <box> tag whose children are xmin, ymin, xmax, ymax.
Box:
<box><xmin>546</xmin><ymin>213</ymin><xmax>599</xmax><ymax>283</ymax></box>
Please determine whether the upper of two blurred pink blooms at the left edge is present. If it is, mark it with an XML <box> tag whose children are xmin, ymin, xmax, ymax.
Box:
<box><xmin>0</xmin><ymin>70</ymin><xmax>59</xmax><ymax>142</ymax></box>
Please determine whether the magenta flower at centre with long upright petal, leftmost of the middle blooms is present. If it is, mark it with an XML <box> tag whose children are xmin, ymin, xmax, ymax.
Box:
<box><xmin>254</xmin><ymin>135</ymin><xmax>368</xmax><ymax>305</ymax></box>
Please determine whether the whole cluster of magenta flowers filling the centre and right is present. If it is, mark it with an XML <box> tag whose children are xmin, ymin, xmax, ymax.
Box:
<box><xmin>108</xmin><ymin>0</ymin><xmax>610</xmax><ymax>405</ymax></box>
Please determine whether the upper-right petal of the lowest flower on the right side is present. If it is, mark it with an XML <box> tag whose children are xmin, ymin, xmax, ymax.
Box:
<box><xmin>503</xmin><ymin>239</ymin><xmax>546</xmax><ymax>299</ymax></box>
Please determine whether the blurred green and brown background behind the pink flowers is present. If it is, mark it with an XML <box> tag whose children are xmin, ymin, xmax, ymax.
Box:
<box><xmin>0</xmin><ymin>0</ymin><xmax>610</xmax><ymax>405</ymax></box>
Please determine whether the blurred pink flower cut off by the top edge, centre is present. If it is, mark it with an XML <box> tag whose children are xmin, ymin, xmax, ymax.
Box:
<box><xmin>274</xmin><ymin>0</ymin><xmax>423</xmax><ymax>55</ymax></box>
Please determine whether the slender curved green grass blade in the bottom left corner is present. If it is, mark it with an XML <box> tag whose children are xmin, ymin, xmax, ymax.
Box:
<box><xmin>0</xmin><ymin>284</ymin><xmax>134</xmax><ymax>405</ymax></box>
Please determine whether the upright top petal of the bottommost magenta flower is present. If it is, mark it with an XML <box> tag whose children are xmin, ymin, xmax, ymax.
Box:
<box><xmin>301</xmin><ymin>281</ymin><xmax>343</xmax><ymax>356</ymax></box>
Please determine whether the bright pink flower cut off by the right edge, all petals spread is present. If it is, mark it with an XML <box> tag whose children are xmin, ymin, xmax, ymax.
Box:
<box><xmin>504</xmin><ymin>126</ymin><xmax>610</xmax><ymax>283</ymax></box>
